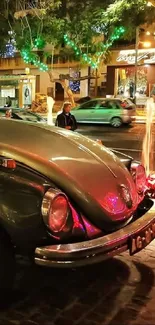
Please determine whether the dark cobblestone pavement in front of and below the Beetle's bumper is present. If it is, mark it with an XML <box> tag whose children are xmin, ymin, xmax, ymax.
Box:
<box><xmin>0</xmin><ymin>239</ymin><xmax>155</xmax><ymax>325</ymax></box>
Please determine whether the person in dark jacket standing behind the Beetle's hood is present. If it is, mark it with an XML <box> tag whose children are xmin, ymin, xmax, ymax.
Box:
<box><xmin>55</xmin><ymin>102</ymin><xmax>77</xmax><ymax>131</ymax></box>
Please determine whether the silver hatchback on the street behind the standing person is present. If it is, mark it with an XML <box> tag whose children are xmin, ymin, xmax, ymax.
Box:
<box><xmin>72</xmin><ymin>98</ymin><xmax>136</xmax><ymax>128</ymax></box>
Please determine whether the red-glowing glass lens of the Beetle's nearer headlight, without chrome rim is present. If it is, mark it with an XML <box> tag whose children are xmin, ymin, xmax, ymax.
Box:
<box><xmin>48</xmin><ymin>195</ymin><xmax>68</xmax><ymax>232</ymax></box>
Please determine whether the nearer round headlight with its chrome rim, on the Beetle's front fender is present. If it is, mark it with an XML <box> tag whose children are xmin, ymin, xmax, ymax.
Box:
<box><xmin>41</xmin><ymin>189</ymin><xmax>70</xmax><ymax>233</ymax></box>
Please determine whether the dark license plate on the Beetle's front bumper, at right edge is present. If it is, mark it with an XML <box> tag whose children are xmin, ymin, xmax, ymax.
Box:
<box><xmin>129</xmin><ymin>220</ymin><xmax>155</xmax><ymax>255</ymax></box>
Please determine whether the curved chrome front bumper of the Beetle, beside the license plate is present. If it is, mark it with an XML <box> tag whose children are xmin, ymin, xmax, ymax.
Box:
<box><xmin>35</xmin><ymin>197</ymin><xmax>155</xmax><ymax>268</ymax></box>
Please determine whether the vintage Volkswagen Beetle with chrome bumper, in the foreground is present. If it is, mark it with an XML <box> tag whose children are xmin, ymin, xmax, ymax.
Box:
<box><xmin>0</xmin><ymin>119</ymin><xmax>155</xmax><ymax>289</ymax></box>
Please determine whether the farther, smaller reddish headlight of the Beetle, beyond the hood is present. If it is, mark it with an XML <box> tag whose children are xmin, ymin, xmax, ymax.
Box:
<box><xmin>130</xmin><ymin>161</ymin><xmax>146</xmax><ymax>195</ymax></box>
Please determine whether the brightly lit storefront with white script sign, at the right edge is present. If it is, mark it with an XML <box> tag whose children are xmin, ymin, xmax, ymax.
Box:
<box><xmin>107</xmin><ymin>49</ymin><xmax>155</xmax><ymax>98</ymax></box>
